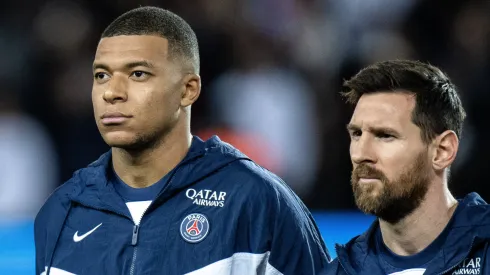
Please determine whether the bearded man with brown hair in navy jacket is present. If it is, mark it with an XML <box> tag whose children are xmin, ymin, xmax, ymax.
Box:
<box><xmin>322</xmin><ymin>60</ymin><xmax>490</xmax><ymax>274</ymax></box>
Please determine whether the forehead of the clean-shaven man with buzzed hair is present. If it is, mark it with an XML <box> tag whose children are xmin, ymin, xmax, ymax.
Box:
<box><xmin>95</xmin><ymin>35</ymin><xmax>168</xmax><ymax>66</ymax></box>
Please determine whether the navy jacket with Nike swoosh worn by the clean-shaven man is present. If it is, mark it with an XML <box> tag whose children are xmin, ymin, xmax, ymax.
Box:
<box><xmin>34</xmin><ymin>137</ymin><xmax>330</xmax><ymax>275</ymax></box>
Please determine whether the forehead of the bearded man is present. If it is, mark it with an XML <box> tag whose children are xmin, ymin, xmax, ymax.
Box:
<box><xmin>351</xmin><ymin>92</ymin><xmax>415</xmax><ymax>128</ymax></box>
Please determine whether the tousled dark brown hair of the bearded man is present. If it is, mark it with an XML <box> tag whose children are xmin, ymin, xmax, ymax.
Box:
<box><xmin>342</xmin><ymin>60</ymin><xmax>466</xmax><ymax>143</ymax></box>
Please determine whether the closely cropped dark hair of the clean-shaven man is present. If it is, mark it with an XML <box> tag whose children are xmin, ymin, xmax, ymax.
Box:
<box><xmin>101</xmin><ymin>6</ymin><xmax>200</xmax><ymax>73</ymax></box>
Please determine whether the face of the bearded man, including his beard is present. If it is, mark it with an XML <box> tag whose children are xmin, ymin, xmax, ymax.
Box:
<box><xmin>348</xmin><ymin>92</ymin><xmax>431</xmax><ymax>223</ymax></box>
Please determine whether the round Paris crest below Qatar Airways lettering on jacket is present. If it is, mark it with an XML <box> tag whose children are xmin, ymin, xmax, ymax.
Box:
<box><xmin>180</xmin><ymin>213</ymin><xmax>209</xmax><ymax>243</ymax></box>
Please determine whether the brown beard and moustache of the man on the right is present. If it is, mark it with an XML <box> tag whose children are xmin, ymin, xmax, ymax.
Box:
<box><xmin>351</xmin><ymin>152</ymin><xmax>430</xmax><ymax>224</ymax></box>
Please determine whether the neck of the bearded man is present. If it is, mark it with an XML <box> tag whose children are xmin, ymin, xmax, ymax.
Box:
<box><xmin>379</xmin><ymin>184</ymin><xmax>457</xmax><ymax>256</ymax></box>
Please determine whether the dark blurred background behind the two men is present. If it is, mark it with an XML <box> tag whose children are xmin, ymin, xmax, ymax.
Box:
<box><xmin>0</xmin><ymin>0</ymin><xmax>490</xmax><ymax>274</ymax></box>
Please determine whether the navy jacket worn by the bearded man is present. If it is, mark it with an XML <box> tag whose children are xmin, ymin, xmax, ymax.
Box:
<box><xmin>321</xmin><ymin>193</ymin><xmax>490</xmax><ymax>275</ymax></box>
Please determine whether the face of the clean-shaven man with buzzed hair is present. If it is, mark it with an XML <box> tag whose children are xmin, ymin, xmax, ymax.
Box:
<box><xmin>92</xmin><ymin>35</ymin><xmax>185</xmax><ymax>149</ymax></box>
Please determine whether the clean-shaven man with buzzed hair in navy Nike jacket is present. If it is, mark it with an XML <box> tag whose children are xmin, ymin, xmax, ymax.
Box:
<box><xmin>35</xmin><ymin>7</ymin><xmax>329</xmax><ymax>275</ymax></box>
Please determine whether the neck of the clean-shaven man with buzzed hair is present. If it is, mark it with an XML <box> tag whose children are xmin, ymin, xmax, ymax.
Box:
<box><xmin>112</xmin><ymin>123</ymin><xmax>192</xmax><ymax>188</ymax></box>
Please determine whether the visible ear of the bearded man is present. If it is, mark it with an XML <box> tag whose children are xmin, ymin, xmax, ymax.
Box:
<box><xmin>432</xmin><ymin>130</ymin><xmax>459</xmax><ymax>170</ymax></box>
